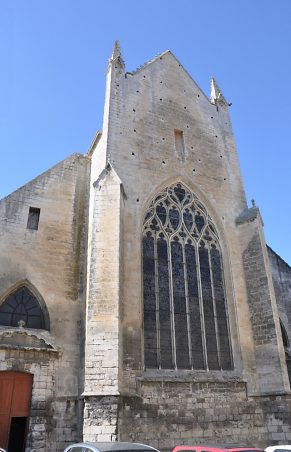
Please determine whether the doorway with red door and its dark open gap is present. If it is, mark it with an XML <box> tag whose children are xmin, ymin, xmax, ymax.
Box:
<box><xmin>0</xmin><ymin>372</ymin><xmax>33</xmax><ymax>452</ymax></box>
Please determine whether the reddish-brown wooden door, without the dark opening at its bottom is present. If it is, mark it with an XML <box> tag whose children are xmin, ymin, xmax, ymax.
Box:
<box><xmin>0</xmin><ymin>372</ymin><xmax>32</xmax><ymax>449</ymax></box>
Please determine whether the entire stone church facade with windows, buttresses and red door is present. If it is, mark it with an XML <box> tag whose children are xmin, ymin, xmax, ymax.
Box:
<box><xmin>0</xmin><ymin>43</ymin><xmax>291</xmax><ymax>451</ymax></box>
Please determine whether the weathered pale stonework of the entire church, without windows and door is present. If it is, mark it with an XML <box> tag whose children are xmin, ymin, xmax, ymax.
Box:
<box><xmin>0</xmin><ymin>46</ymin><xmax>291</xmax><ymax>451</ymax></box>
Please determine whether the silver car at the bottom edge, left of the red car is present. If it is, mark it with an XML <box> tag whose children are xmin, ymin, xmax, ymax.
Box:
<box><xmin>64</xmin><ymin>442</ymin><xmax>159</xmax><ymax>452</ymax></box>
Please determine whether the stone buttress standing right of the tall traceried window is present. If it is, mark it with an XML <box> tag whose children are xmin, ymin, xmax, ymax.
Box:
<box><xmin>239</xmin><ymin>216</ymin><xmax>290</xmax><ymax>395</ymax></box>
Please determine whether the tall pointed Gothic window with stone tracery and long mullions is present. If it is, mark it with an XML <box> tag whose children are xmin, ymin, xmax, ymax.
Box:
<box><xmin>143</xmin><ymin>183</ymin><xmax>232</xmax><ymax>370</ymax></box>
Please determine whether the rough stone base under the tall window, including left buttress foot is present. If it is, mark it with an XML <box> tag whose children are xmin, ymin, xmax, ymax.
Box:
<box><xmin>84</xmin><ymin>382</ymin><xmax>291</xmax><ymax>452</ymax></box>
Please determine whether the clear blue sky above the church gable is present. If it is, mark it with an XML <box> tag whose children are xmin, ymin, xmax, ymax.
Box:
<box><xmin>0</xmin><ymin>0</ymin><xmax>291</xmax><ymax>264</ymax></box>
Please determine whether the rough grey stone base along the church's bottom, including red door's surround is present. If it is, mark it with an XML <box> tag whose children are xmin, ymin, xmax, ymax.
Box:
<box><xmin>0</xmin><ymin>366</ymin><xmax>291</xmax><ymax>452</ymax></box>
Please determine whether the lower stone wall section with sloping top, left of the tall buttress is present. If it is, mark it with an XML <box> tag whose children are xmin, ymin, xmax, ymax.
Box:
<box><xmin>0</xmin><ymin>155</ymin><xmax>89</xmax><ymax>451</ymax></box>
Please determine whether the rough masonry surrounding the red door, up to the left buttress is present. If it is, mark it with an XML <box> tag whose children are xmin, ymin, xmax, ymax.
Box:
<box><xmin>0</xmin><ymin>349</ymin><xmax>83</xmax><ymax>452</ymax></box>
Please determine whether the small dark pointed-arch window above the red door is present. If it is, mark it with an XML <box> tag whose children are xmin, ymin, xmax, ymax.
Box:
<box><xmin>0</xmin><ymin>285</ymin><xmax>48</xmax><ymax>329</ymax></box>
